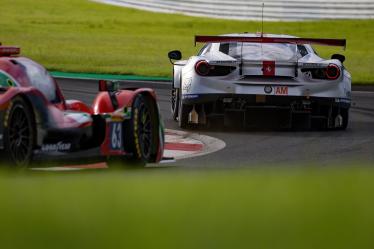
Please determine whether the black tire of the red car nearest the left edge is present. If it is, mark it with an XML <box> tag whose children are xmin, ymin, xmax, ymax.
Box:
<box><xmin>4</xmin><ymin>97</ymin><xmax>36</xmax><ymax>168</ymax></box>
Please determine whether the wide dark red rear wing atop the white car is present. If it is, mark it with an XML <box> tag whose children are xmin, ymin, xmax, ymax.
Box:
<box><xmin>195</xmin><ymin>35</ymin><xmax>346</xmax><ymax>49</ymax></box>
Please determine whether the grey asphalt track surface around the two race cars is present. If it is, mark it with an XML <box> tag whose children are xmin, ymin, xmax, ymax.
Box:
<box><xmin>57</xmin><ymin>79</ymin><xmax>374</xmax><ymax>168</ymax></box>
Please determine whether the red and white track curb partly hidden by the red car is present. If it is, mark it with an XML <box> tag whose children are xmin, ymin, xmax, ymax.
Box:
<box><xmin>32</xmin><ymin>129</ymin><xmax>226</xmax><ymax>171</ymax></box>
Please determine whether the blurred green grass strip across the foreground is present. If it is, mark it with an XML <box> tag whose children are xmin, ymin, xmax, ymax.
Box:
<box><xmin>0</xmin><ymin>167</ymin><xmax>374</xmax><ymax>249</ymax></box>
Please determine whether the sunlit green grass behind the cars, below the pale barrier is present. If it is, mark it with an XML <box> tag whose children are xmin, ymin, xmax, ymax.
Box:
<box><xmin>0</xmin><ymin>0</ymin><xmax>374</xmax><ymax>83</ymax></box>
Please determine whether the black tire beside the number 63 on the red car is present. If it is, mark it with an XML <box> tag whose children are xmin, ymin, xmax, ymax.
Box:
<box><xmin>124</xmin><ymin>94</ymin><xmax>159</xmax><ymax>165</ymax></box>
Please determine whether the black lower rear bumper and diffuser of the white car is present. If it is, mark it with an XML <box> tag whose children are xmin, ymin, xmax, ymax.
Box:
<box><xmin>182</xmin><ymin>94</ymin><xmax>351</xmax><ymax>129</ymax></box>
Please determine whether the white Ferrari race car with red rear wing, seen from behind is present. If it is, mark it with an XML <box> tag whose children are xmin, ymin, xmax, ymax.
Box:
<box><xmin>168</xmin><ymin>33</ymin><xmax>351</xmax><ymax>129</ymax></box>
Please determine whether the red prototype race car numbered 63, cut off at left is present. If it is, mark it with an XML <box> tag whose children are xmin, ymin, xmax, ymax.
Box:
<box><xmin>0</xmin><ymin>44</ymin><xmax>164</xmax><ymax>166</ymax></box>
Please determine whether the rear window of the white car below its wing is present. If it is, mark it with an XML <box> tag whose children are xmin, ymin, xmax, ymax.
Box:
<box><xmin>220</xmin><ymin>42</ymin><xmax>298</xmax><ymax>61</ymax></box>
